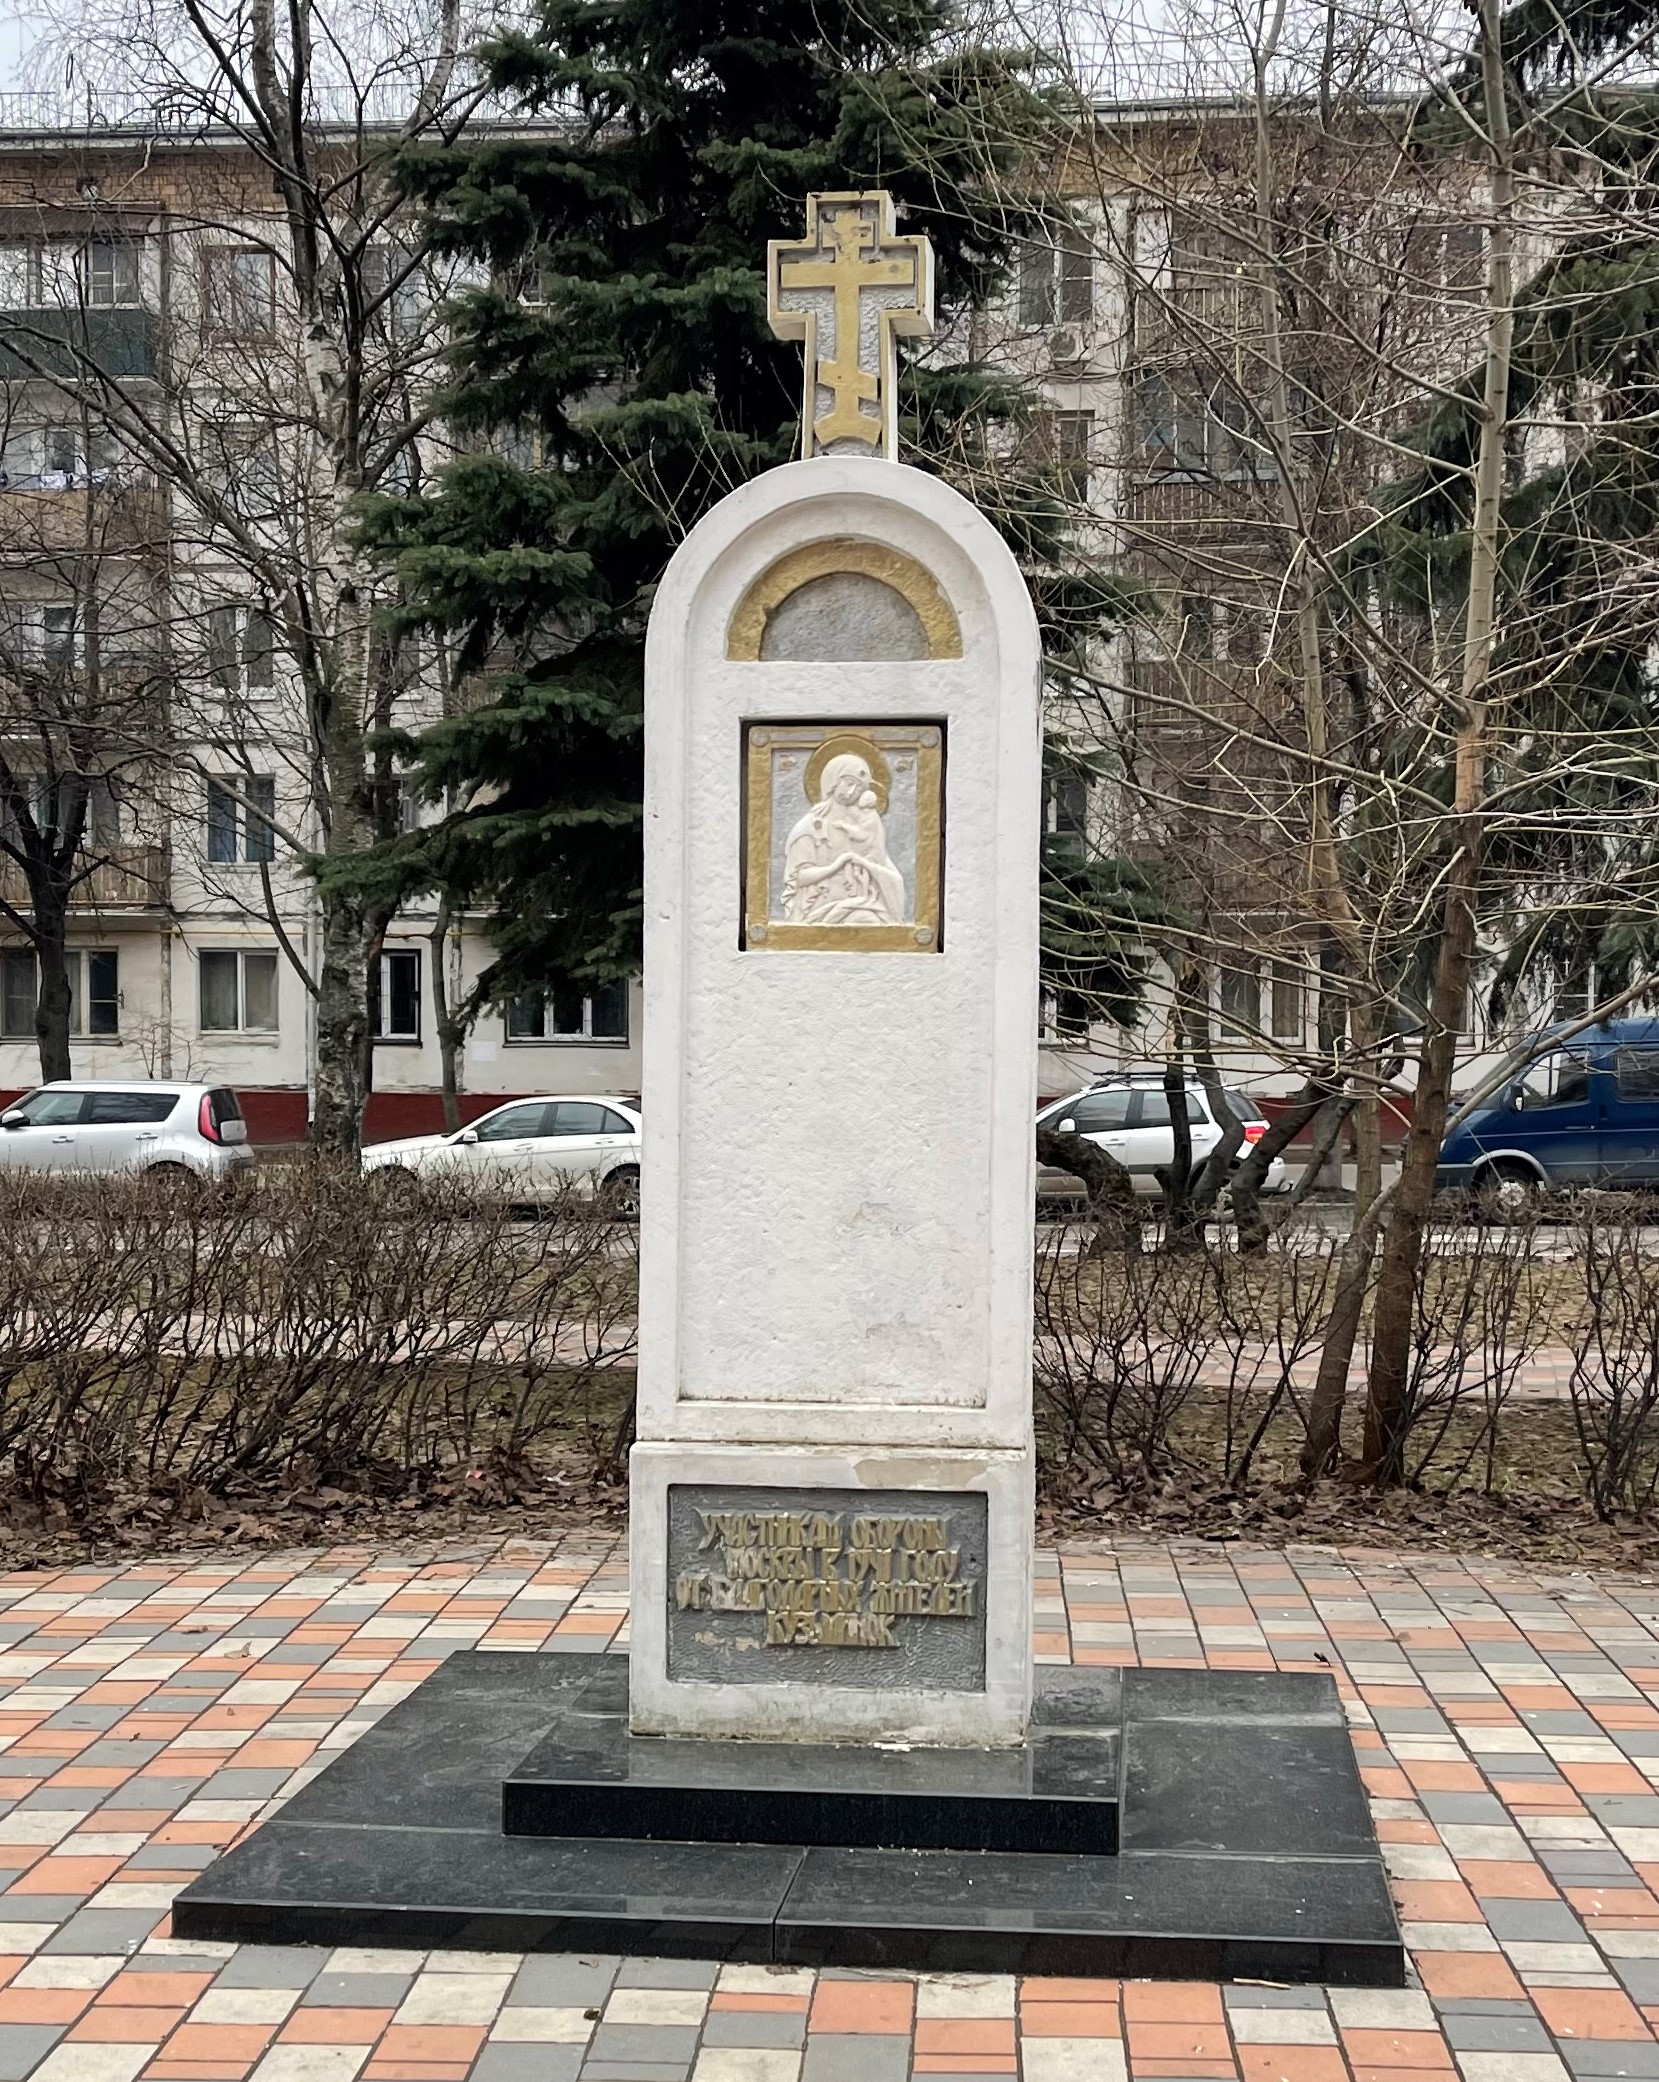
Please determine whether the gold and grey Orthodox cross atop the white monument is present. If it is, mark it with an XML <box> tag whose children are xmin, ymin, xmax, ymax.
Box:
<box><xmin>766</xmin><ymin>187</ymin><xmax>933</xmax><ymax>456</ymax></box>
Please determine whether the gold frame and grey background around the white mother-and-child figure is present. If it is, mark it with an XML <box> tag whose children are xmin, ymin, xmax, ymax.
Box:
<box><xmin>739</xmin><ymin>718</ymin><xmax>945</xmax><ymax>954</ymax></box>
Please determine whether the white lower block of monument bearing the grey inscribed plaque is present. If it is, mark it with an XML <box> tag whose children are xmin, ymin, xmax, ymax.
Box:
<box><xmin>629</xmin><ymin>1443</ymin><xmax>1032</xmax><ymax>1749</ymax></box>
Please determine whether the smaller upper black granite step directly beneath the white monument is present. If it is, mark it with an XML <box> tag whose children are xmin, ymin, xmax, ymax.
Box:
<box><xmin>502</xmin><ymin>1657</ymin><xmax>1120</xmax><ymax>1857</ymax></box>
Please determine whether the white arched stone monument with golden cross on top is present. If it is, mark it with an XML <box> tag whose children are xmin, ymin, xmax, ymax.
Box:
<box><xmin>631</xmin><ymin>194</ymin><xmax>1041</xmax><ymax>1745</ymax></box>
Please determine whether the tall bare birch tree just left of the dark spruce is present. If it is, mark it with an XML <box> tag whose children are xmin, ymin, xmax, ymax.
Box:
<box><xmin>6</xmin><ymin>0</ymin><xmax>477</xmax><ymax>1151</ymax></box>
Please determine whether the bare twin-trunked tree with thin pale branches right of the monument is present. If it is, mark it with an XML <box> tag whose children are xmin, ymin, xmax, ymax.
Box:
<box><xmin>970</xmin><ymin>0</ymin><xmax>1659</xmax><ymax>1480</ymax></box>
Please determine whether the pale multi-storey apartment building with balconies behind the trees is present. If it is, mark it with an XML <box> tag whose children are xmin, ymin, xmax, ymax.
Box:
<box><xmin>0</xmin><ymin>102</ymin><xmax>1540</xmax><ymax>1139</ymax></box>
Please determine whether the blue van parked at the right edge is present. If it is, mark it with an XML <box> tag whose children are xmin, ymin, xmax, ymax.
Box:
<box><xmin>1434</xmin><ymin>1020</ymin><xmax>1659</xmax><ymax>1220</ymax></box>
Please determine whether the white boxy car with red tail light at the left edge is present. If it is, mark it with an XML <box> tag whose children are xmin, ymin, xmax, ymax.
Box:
<box><xmin>0</xmin><ymin>1076</ymin><xmax>254</xmax><ymax>1180</ymax></box>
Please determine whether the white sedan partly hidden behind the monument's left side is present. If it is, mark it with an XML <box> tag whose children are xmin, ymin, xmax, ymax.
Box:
<box><xmin>362</xmin><ymin>1095</ymin><xmax>641</xmax><ymax>1214</ymax></box>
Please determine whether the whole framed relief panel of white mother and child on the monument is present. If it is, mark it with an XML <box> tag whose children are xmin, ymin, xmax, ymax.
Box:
<box><xmin>743</xmin><ymin>722</ymin><xmax>943</xmax><ymax>954</ymax></box>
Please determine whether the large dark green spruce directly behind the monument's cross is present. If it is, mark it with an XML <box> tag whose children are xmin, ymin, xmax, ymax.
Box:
<box><xmin>368</xmin><ymin>0</ymin><xmax>1116</xmax><ymax>997</ymax></box>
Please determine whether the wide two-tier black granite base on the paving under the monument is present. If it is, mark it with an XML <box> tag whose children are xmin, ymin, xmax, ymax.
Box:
<box><xmin>173</xmin><ymin>1651</ymin><xmax>1405</xmax><ymax>1986</ymax></box>
